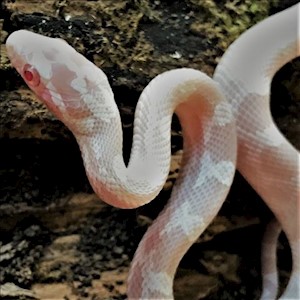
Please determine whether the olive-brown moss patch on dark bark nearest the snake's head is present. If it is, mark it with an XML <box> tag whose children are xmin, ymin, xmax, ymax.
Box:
<box><xmin>85</xmin><ymin>0</ymin><xmax>159</xmax><ymax>70</ymax></box>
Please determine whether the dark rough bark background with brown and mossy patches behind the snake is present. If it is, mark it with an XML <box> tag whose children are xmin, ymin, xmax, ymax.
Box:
<box><xmin>0</xmin><ymin>0</ymin><xmax>300</xmax><ymax>300</ymax></box>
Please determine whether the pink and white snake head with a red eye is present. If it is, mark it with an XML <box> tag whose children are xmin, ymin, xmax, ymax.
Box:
<box><xmin>6</xmin><ymin>30</ymin><xmax>115</xmax><ymax>134</ymax></box>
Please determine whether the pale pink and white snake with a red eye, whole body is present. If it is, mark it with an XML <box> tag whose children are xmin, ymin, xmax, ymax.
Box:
<box><xmin>6</xmin><ymin>4</ymin><xmax>300</xmax><ymax>299</ymax></box>
